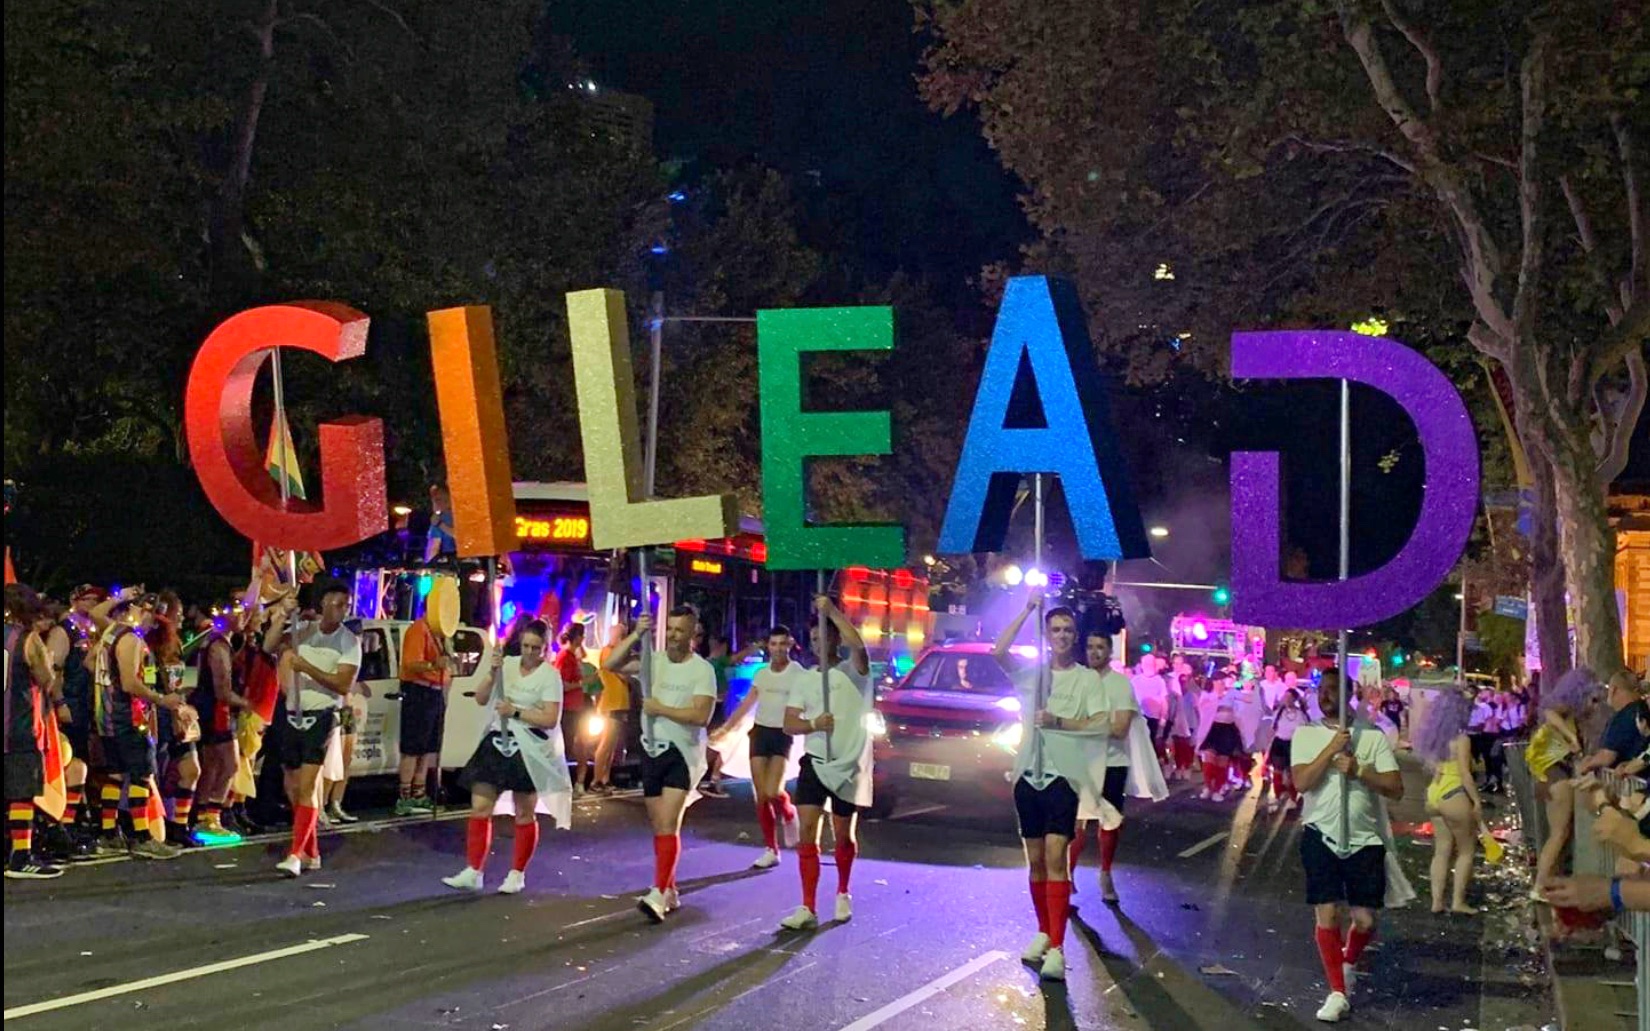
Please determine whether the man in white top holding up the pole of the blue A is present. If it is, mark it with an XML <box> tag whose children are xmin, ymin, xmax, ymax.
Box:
<box><xmin>992</xmin><ymin>594</ymin><xmax>1114</xmax><ymax>982</ymax></box>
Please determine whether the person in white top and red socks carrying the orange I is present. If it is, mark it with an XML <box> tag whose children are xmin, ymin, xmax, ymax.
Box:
<box><xmin>442</xmin><ymin>620</ymin><xmax>573</xmax><ymax>896</ymax></box>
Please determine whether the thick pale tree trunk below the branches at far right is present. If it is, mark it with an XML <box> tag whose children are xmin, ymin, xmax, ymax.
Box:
<box><xmin>1533</xmin><ymin>432</ymin><xmax>1625</xmax><ymax>680</ymax></box>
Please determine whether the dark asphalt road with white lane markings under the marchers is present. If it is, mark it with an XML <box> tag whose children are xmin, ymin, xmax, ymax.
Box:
<box><xmin>3</xmin><ymin>765</ymin><xmax>1551</xmax><ymax>1031</ymax></box>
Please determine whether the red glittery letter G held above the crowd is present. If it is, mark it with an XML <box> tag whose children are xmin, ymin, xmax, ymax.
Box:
<box><xmin>183</xmin><ymin>302</ymin><xmax>389</xmax><ymax>551</ymax></box>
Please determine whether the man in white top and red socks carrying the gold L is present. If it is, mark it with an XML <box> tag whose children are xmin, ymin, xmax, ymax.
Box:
<box><xmin>607</xmin><ymin>605</ymin><xmax>716</xmax><ymax>924</ymax></box>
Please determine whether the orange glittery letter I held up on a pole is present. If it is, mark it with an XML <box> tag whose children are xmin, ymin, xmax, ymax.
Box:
<box><xmin>427</xmin><ymin>307</ymin><xmax>515</xmax><ymax>558</ymax></box>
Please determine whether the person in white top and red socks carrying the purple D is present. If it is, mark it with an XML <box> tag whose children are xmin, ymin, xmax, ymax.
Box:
<box><xmin>1290</xmin><ymin>670</ymin><xmax>1404</xmax><ymax>1023</ymax></box>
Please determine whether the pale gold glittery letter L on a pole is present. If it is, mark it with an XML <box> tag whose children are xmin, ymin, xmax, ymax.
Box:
<box><xmin>568</xmin><ymin>290</ymin><xmax>739</xmax><ymax>549</ymax></box>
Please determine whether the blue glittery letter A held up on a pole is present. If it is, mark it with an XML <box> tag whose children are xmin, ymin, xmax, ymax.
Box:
<box><xmin>939</xmin><ymin>275</ymin><xmax>1152</xmax><ymax>561</ymax></box>
